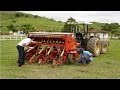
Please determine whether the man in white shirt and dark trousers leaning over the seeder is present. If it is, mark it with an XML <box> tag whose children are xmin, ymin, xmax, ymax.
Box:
<box><xmin>17</xmin><ymin>38</ymin><xmax>40</xmax><ymax>67</ymax></box>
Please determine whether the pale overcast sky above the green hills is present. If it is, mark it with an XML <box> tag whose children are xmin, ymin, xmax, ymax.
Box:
<box><xmin>21</xmin><ymin>11</ymin><xmax>120</xmax><ymax>24</ymax></box>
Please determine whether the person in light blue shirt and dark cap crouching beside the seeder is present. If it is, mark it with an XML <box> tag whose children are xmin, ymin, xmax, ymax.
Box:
<box><xmin>78</xmin><ymin>48</ymin><xmax>93</xmax><ymax>64</ymax></box>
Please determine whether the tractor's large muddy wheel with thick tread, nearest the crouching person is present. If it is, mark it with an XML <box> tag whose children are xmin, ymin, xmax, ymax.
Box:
<box><xmin>87</xmin><ymin>37</ymin><xmax>101</xmax><ymax>56</ymax></box>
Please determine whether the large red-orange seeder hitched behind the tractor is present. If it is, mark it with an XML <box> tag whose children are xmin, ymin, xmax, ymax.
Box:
<box><xmin>26</xmin><ymin>32</ymin><xmax>79</xmax><ymax>67</ymax></box>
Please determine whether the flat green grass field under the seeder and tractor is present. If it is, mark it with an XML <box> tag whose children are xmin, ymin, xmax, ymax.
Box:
<box><xmin>0</xmin><ymin>40</ymin><xmax>120</xmax><ymax>79</ymax></box>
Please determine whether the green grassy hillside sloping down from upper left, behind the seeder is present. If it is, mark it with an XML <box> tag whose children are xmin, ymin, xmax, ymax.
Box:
<box><xmin>0</xmin><ymin>11</ymin><xmax>64</xmax><ymax>32</ymax></box>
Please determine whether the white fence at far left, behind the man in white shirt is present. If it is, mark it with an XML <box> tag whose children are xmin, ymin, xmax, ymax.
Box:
<box><xmin>0</xmin><ymin>35</ymin><xmax>26</xmax><ymax>40</ymax></box>
